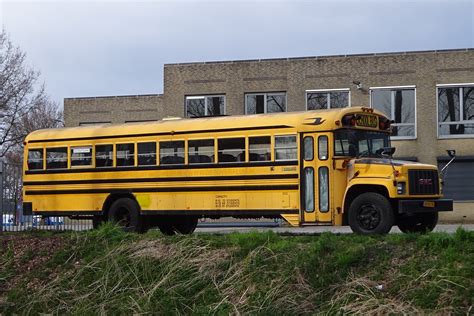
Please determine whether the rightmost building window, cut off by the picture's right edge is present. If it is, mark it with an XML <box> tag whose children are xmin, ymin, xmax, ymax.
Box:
<box><xmin>437</xmin><ymin>84</ymin><xmax>474</xmax><ymax>137</ymax></box>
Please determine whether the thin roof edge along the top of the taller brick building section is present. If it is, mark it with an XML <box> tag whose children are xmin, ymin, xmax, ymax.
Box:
<box><xmin>164</xmin><ymin>48</ymin><xmax>474</xmax><ymax>67</ymax></box>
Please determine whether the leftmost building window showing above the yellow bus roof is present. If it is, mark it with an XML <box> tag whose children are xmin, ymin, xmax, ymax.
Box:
<box><xmin>185</xmin><ymin>95</ymin><xmax>225</xmax><ymax>117</ymax></box>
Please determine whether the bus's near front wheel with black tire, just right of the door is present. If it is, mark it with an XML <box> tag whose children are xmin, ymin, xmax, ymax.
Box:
<box><xmin>349</xmin><ymin>192</ymin><xmax>395</xmax><ymax>235</ymax></box>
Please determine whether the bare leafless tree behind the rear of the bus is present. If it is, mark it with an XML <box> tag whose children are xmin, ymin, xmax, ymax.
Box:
<box><xmin>0</xmin><ymin>30</ymin><xmax>63</xmax><ymax>221</ymax></box>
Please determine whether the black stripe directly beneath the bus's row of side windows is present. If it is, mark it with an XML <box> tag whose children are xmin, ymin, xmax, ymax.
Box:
<box><xmin>25</xmin><ymin>160</ymin><xmax>298</xmax><ymax>174</ymax></box>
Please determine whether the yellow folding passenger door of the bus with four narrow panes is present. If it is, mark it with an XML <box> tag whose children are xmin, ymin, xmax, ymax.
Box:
<box><xmin>301</xmin><ymin>133</ymin><xmax>331</xmax><ymax>224</ymax></box>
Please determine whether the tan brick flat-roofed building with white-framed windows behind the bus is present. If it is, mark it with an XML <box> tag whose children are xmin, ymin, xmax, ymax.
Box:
<box><xmin>64</xmin><ymin>49</ymin><xmax>474</xmax><ymax>220</ymax></box>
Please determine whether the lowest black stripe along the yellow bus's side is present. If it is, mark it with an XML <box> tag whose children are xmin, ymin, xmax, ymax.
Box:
<box><xmin>25</xmin><ymin>185</ymin><xmax>298</xmax><ymax>195</ymax></box>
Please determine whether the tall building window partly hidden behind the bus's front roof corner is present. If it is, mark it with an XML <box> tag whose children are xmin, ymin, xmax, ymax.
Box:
<box><xmin>370</xmin><ymin>87</ymin><xmax>416</xmax><ymax>139</ymax></box>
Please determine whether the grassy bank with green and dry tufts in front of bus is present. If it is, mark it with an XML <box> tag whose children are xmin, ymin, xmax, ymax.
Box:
<box><xmin>0</xmin><ymin>225</ymin><xmax>474</xmax><ymax>315</ymax></box>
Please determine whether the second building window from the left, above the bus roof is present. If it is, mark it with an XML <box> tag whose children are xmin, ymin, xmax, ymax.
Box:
<box><xmin>245</xmin><ymin>92</ymin><xmax>286</xmax><ymax>114</ymax></box>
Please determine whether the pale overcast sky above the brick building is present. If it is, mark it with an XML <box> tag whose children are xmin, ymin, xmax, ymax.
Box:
<box><xmin>0</xmin><ymin>0</ymin><xmax>474</xmax><ymax>104</ymax></box>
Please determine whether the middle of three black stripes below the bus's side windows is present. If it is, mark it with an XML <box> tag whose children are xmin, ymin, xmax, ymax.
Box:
<box><xmin>23</xmin><ymin>173</ymin><xmax>298</xmax><ymax>186</ymax></box>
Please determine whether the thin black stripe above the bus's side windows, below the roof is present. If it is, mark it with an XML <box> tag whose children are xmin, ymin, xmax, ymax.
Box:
<box><xmin>28</xmin><ymin>125</ymin><xmax>292</xmax><ymax>144</ymax></box>
